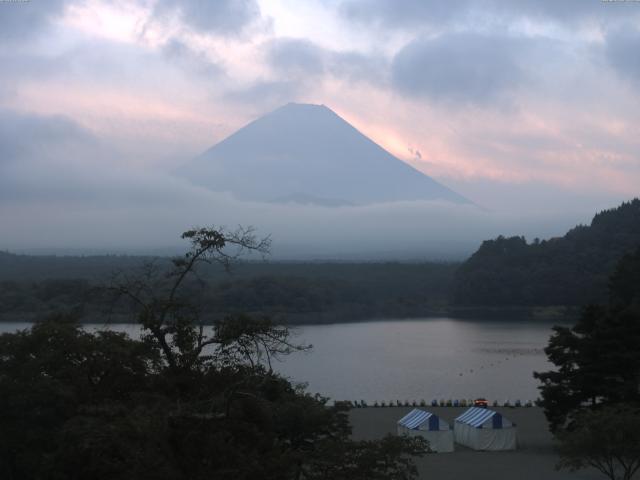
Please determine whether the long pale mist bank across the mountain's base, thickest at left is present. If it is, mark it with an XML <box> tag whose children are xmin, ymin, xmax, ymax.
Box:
<box><xmin>0</xmin><ymin>111</ymin><xmax>589</xmax><ymax>260</ymax></box>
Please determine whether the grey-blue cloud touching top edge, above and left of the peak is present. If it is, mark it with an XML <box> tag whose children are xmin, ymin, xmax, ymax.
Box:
<box><xmin>155</xmin><ymin>0</ymin><xmax>260</xmax><ymax>35</ymax></box>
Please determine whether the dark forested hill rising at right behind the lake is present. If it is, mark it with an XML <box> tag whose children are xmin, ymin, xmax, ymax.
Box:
<box><xmin>453</xmin><ymin>199</ymin><xmax>640</xmax><ymax>306</ymax></box>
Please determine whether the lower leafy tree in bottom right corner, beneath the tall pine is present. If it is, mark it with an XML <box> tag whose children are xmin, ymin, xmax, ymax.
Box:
<box><xmin>558</xmin><ymin>406</ymin><xmax>640</xmax><ymax>480</ymax></box>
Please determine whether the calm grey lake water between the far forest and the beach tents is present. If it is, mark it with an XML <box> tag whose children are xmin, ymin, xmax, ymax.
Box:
<box><xmin>0</xmin><ymin>318</ymin><xmax>552</xmax><ymax>402</ymax></box>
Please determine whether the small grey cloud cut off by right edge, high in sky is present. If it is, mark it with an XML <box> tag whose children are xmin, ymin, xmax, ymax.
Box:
<box><xmin>605</xmin><ymin>24</ymin><xmax>640</xmax><ymax>87</ymax></box>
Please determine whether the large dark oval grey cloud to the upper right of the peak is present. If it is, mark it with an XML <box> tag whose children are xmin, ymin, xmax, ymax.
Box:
<box><xmin>391</xmin><ymin>33</ymin><xmax>524</xmax><ymax>104</ymax></box>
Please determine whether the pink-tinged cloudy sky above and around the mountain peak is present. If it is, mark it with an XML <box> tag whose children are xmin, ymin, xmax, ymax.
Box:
<box><xmin>0</xmin><ymin>0</ymin><xmax>640</xmax><ymax>256</ymax></box>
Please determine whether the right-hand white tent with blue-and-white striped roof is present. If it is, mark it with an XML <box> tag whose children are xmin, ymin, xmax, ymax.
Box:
<box><xmin>454</xmin><ymin>407</ymin><xmax>516</xmax><ymax>450</ymax></box>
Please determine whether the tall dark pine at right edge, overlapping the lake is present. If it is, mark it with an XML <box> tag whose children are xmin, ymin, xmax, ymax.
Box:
<box><xmin>534</xmin><ymin>249</ymin><xmax>640</xmax><ymax>432</ymax></box>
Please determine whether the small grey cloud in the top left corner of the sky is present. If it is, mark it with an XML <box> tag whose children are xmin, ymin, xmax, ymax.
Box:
<box><xmin>0</xmin><ymin>0</ymin><xmax>67</xmax><ymax>42</ymax></box>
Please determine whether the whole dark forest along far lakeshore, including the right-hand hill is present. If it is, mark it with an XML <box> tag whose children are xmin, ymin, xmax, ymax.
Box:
<box><xmin>0</xmin><ymin>199</ymin><xmax>640</xmax><ymax>323</ymax></box>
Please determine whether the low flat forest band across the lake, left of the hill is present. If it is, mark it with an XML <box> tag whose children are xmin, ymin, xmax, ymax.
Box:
<box><xmin>0</xmin><ymin>254</ymin><xmax>457</xmax><ymax>323</ymax></box>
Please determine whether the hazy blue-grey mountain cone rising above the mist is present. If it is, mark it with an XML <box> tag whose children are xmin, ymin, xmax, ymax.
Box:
<box><xmin>179</xmin><ymin>103</ymin><xmax>469</xmax><ymax>206</ymax></box>
